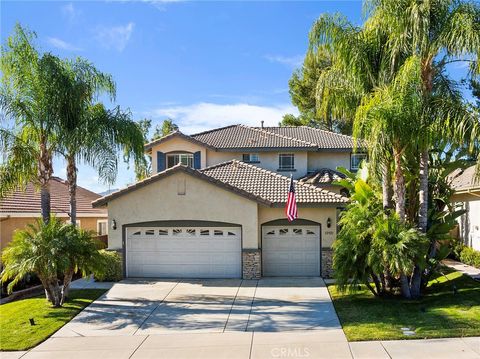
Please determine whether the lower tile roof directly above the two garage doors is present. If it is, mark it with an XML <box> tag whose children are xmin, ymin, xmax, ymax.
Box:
<box><xmin>93</xmin><ymin>160</ymin><xmax>348</xmax><ymax>207</ymax></box>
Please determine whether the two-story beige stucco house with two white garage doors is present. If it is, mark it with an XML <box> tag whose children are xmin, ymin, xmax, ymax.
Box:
<box><xmin>93</xmin><ymin>125</ymin><xmax>365</xmax><ymax>279</ymax></box>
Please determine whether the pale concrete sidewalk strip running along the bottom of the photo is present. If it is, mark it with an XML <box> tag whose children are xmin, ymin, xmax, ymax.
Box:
<box><xmin>0</xmin><ymin>330</ymin><xmax>480</xmax><ymax>359</ymax></box>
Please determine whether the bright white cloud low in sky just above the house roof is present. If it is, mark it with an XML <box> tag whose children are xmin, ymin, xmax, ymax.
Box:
<box><xmin>145</xmin><ymin>102</ymin><xmax>298</xmax><ymax>134</ymax></box>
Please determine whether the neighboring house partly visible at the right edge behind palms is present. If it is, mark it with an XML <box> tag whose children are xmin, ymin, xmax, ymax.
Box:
<box><xmin>450</xmin><ymin>166</ymin><xmax>480</xmax><ymax>251</ymax></box>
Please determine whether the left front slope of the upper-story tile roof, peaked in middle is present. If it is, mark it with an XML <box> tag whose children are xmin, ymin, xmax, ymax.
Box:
<box><xmin>191</xmin><ymin>125</ymin><xmax>318</xmax><ymax>150</ymax></box>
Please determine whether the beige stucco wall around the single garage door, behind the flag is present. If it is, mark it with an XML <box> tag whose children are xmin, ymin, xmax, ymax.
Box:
<box><xmin>258</xmin><ymin>205</ymin><xmax>337</xmax><ymax>247</ymax></box>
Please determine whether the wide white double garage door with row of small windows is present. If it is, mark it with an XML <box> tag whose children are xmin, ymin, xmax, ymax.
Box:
<box><xmin>126</xmin><ymin>227</ymin><xmax>241</xmax><ymax>278</ymax></box>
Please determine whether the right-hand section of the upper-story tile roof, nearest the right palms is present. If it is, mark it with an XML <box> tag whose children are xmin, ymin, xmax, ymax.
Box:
<box><xmin>258</xmin><ymin>126</ymin><xmax>354</xmax><ymax>149</ymax></box>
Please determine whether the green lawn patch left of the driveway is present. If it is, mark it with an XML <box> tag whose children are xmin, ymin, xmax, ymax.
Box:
<box><xmin>0</xmin><ymin>289</ymin><xmax>105</xmax><ymax>350</ymax></box>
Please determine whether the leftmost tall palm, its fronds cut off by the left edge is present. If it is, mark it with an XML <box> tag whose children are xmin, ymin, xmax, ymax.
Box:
<box><xmin>0</xmin><ymin>24</ymin><xmax>65</xmax><ymax>222</ymax></box>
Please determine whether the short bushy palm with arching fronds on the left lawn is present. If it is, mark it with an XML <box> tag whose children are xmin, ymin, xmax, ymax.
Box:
<box><xmin>0</xmin><ymin>217</ymin><xmax>103</xmax><ymax>307</ymax></box>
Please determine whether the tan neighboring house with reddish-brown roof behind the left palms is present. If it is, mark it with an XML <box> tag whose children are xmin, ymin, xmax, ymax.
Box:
<box><xmin>0</xmin><ymin>177</ymin><xmax>108</xmax><ymax>249</ymax></box>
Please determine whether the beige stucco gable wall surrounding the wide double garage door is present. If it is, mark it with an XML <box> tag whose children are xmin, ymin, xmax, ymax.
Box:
<box><xmin>108</xmin><ymin>173</ymin><xmax>258</xmax><ymax>249</ymax></box>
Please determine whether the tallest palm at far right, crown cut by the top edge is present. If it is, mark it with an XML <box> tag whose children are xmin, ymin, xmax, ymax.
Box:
<box><xmin>367</xmin><ymin>0</ymin><xmax>480</xmax><ymax>236</ymax></box>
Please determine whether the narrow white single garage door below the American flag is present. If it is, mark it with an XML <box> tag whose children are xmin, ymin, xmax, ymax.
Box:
<box><xmin>262</xmin><ymin>226</ymin><xmax>320</xmax><ymax>277</ymax></box>
